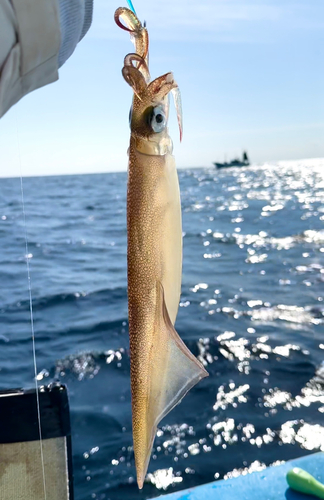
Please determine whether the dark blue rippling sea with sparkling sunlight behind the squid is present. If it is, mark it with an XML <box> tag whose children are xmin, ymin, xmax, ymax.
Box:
<box><xmin>0</xmin><ymin>160</ymin><xmax>324</xmax><ymax>500</ymax></box>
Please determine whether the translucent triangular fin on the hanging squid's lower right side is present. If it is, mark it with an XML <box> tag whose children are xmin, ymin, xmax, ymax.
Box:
<box><xmin>136</xmin><ymin>283</ymin><xmax>208</xmax><ymax>488</ymax></box>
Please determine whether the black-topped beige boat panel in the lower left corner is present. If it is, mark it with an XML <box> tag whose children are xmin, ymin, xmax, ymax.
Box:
<box><xmin>0</xmin><ymin>382</ymin><xmax>74</xmax><ymax>500</ymax></box>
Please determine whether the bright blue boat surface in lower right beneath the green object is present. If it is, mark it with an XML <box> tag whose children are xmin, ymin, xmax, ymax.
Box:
<box><xmin>160</xmin><ymin>453</ymin><xmax>324</xmax><ymax>500</ymax></box>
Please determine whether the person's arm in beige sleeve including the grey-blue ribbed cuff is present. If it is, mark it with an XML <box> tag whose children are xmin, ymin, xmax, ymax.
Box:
<box><xmin>0</xmin><ymin>0</ymin><xmax>93</xmax><ymax>117</ymax></box>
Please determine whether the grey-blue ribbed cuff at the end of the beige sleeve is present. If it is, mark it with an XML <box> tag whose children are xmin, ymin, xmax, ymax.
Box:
<box><xmin>58</xmin><ymin>0</ymin><xmax>93</xmax><ymax>67</ymax></box>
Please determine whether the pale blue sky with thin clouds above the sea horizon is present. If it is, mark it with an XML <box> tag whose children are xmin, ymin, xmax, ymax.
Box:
<box><xmin>0</xmin><ymin>0</ymin><xmax>324</xmax><ymax>176</ymax></box>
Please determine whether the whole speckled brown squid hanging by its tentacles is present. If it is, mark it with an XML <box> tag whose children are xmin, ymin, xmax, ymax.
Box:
<box><xmin>115</xmin><ymin>7</ymin><xmax>208</xmax><ymax>489</ymax></box>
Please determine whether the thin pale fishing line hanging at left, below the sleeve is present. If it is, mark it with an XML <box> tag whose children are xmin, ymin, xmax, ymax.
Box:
<box><xmin>16</xmin><ymin>110</ymin><xmax>47</xmax><ymax>500</ymax></box>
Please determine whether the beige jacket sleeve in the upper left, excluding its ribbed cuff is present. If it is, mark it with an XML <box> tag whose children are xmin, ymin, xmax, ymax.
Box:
<box><xmin>0</xmin><ymin>0</ymin><xmax>61</xmax><ymax>116</ymax></box>
